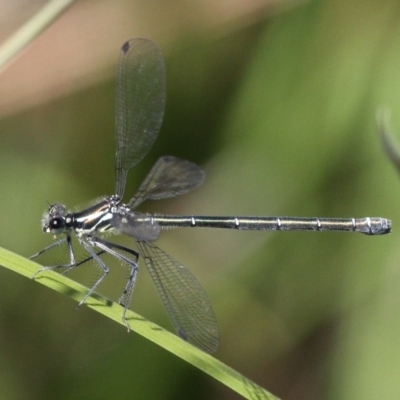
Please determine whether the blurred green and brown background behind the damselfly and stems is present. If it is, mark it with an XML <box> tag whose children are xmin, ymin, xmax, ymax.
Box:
<box><xmin>0</xmin><ymin>0</ymin><xmax>400</xmax><ymax>400</ymax></box>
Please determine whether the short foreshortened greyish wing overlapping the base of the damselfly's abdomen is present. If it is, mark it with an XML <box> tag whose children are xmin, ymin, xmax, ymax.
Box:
<box><xmin>111</xmin><ymin>208</ymin><xmax>161</xmax><ymax>242</ymax></box>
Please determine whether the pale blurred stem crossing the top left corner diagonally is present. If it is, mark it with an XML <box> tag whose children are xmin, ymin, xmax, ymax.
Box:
<box><xmin>0</xmin><ymin>0</ymin><xmax>76</xmax><ymax>72</ymax></box>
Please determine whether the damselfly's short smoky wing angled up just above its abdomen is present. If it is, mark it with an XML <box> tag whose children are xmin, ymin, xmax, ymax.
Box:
<box><xmin>128</xmin><ymin>156</ymin><xmax>204</xmax><ymax>209</ymax></box>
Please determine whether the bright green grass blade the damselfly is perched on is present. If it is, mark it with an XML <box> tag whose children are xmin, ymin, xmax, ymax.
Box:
<box><xmin>0</xmin><ymin>248</ymin><xmax>278</xmax><ymax>400</ymax></box>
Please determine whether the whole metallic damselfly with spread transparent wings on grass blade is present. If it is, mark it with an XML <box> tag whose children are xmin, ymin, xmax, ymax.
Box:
<box><xmin>31</xmin><ymin>39</ymin><xmax>391</xmax><ymax>353</ymax></box>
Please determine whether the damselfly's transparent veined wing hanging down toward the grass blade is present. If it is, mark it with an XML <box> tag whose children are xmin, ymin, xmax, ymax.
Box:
<box><xmin>137</xmin><ymin>241</ymin><xmax>219</xmax><ymax>353</ymax></box>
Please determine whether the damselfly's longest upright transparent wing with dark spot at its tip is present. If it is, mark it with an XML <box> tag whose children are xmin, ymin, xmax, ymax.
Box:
<box><xmin>115</xmin><ymin>39</ymin><xmax>166</xmax><ymax>198</ymax></box>
